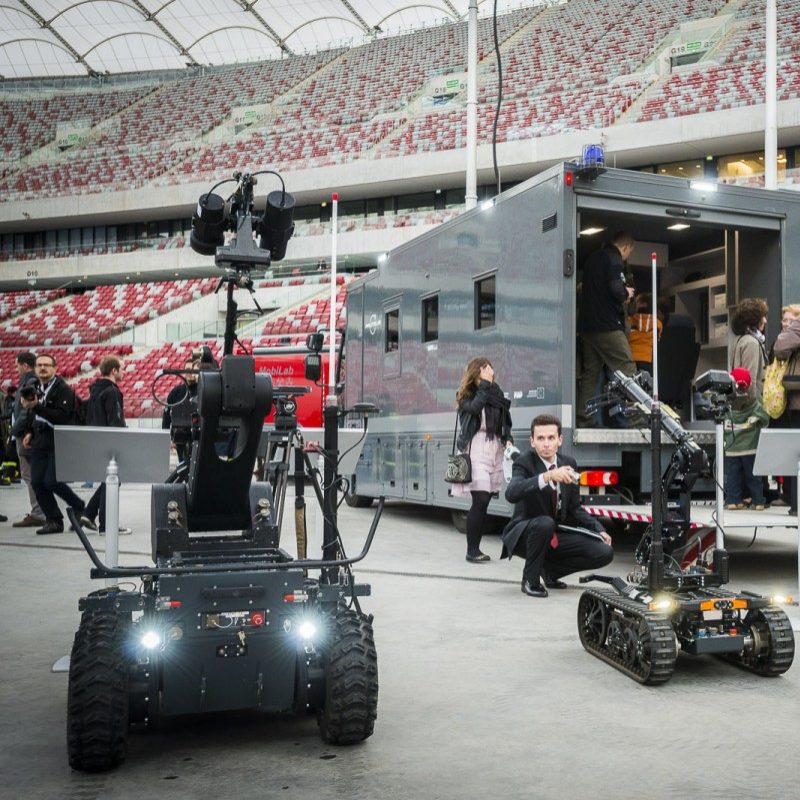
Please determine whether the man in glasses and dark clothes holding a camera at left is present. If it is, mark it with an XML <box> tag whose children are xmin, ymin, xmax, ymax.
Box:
<box><xmin>19</xmin><ymin>353</ymin><xmax>86</xmax><ymax>535</ymax></box>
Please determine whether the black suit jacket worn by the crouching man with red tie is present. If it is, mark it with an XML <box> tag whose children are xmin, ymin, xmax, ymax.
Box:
<box><xmin>501</xmin><ymin>450</ymin><xmax>604</xmax><ymax>558</ymax></box>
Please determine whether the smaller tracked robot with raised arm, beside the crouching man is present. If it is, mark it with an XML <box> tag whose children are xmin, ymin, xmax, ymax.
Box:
<box><xmin>578</xmin><ymin>371</ymin><xmax>794</xmax><ymax>685</ymax></box>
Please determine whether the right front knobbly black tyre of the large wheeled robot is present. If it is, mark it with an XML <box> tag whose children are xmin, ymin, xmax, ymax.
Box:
<box><xmin>317</xmin><ymin>611</ymin><xmax>378</xmax><ymax>744</ymax></box>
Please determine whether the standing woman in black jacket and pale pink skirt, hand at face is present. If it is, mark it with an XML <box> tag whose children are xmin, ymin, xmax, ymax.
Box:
<box><xmin>452</xmin><ymin>356</ymin><xmax>512</xmax><ymax>563</ymax></box>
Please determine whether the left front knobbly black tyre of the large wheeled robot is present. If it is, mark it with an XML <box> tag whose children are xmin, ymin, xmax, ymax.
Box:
<box><xmin>67</xmin><ymin>611</ymin><xmax>128</xmax><ymax>772</ymax></box>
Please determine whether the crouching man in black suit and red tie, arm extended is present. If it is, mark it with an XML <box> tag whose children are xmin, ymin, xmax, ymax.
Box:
<box><xmin>500</xmin><ymin>414</ymin><xmax>614</xmax><ymax>597</ymax></box>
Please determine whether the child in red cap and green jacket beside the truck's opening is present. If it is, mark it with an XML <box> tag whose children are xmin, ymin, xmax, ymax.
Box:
<box><xmin>723</xmin><ymin>367</ymin><xmax>769</xmax><ymax>511</ymax></box>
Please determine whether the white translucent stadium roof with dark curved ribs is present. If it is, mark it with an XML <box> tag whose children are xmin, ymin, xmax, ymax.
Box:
<box><xmin>0</xmin><ymin>0</ymin><xmax>524</xmax><ymax>80</ymax></box>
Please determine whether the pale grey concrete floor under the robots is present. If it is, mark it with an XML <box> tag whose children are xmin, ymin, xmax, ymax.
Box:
<box><xmin>0</xmin><ymin>486</ymin><xmax>800</xmax><ymax>800</ymax></box>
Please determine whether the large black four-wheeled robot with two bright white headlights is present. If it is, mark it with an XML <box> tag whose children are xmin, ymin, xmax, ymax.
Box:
<box><xmin>67</xmin><ymin>176</ymin><xmax>383</xmax><ymax>772</ymax></box>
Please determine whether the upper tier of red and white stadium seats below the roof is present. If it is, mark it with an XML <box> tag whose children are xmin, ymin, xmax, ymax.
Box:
<box><xmin>0</xmin><ymin>0</ymin><xmax>800</xmax><ymax>198</ymax></box>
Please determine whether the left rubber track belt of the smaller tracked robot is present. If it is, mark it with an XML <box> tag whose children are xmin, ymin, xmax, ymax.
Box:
<box><xmin>578</xmin><ymin>589</ymin><xmax>678</xmax><ymax>685</ymax></box>
